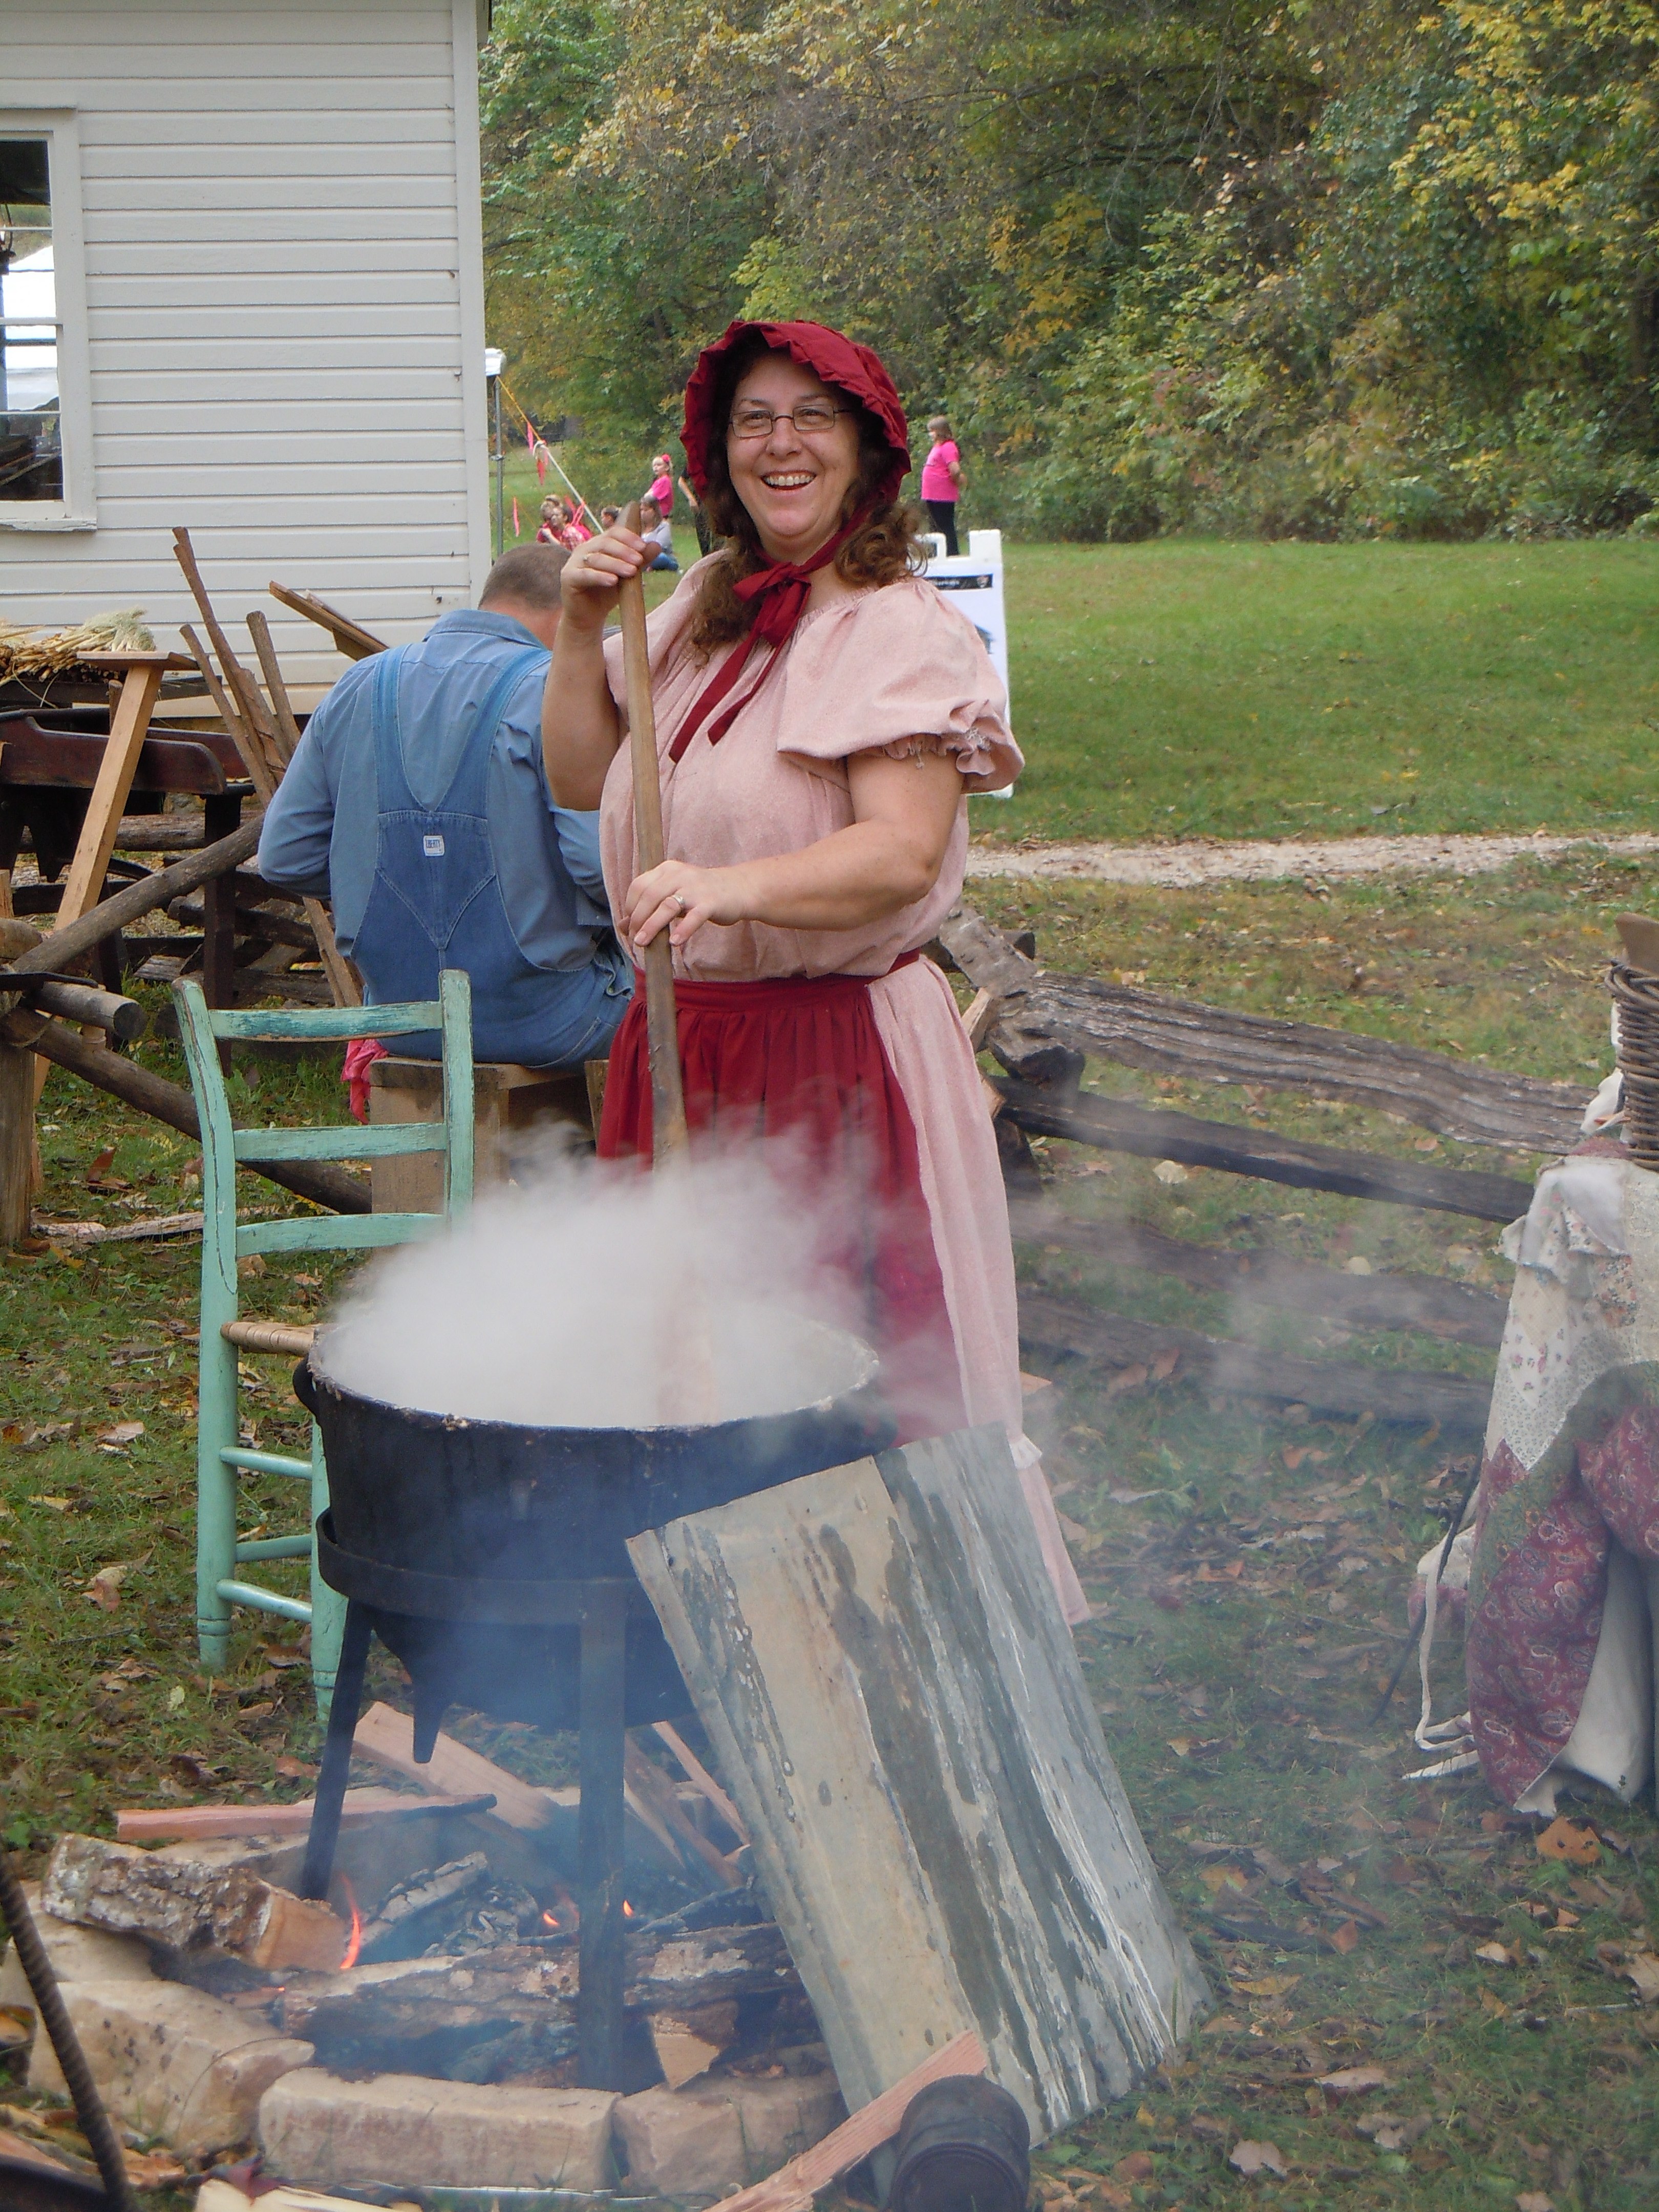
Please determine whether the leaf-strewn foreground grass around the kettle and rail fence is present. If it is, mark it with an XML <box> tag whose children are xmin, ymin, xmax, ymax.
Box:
<box><xmin>0</xmin><ymin>852</ymin><xmax>1659</xmax><ymax>2212</ymax></box>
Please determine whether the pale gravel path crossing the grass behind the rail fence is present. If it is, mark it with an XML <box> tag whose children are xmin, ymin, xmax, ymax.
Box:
<box><xmin>967</xmin><ymin>834</ymin><xmax>1659</xmax><ymax>889</ymax></box>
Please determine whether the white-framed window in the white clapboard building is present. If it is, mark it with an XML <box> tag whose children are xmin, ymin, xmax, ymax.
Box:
<box><xmin>0</xmin><ymin>106</ymin><xmax>93</xmax><ymax>528</ymax></box>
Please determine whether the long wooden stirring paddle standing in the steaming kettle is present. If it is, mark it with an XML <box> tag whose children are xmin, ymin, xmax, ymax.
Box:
<box><xmin>617</xmin><ymin>500</ymin><xmax>719</xmax><ymax>1427</ymax></box>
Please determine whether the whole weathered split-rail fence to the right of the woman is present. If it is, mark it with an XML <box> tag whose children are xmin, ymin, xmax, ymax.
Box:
<box><xmin>933</xmin><ymin>907</ymin><xmax>1539</xmax><ymax>1429</ymax></box>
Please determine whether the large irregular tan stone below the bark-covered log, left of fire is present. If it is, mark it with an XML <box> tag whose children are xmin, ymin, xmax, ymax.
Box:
<box><xmin>29</xmin><ymin>1980</ymin><xmax>312</xmax><ymax>2152</ymax></box>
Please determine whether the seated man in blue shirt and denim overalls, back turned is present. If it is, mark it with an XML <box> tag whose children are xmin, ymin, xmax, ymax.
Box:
<box><xmin>259</xmin><ymin>544</ymin><xmax>633</xmax><ymax>1069</ymax></box>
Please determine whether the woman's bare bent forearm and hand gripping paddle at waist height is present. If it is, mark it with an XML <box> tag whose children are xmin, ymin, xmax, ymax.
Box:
<box><xmin>622</xmin><ymin>752</ymin><xmax>962</xmax><ymax>945</ymax></box>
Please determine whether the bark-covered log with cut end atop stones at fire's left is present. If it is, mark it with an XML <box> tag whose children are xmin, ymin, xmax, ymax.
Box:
<box><xmin>42</xmin><ymin>1836</ymin><xmax>345</xmax><ymax>1969</ymax></box>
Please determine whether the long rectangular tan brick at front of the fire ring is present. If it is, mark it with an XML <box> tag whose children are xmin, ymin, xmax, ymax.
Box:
<box><xmin>259</xmin><ymin>2066</ymin><xmax>617</xmax><ymax>2190</ymax></box>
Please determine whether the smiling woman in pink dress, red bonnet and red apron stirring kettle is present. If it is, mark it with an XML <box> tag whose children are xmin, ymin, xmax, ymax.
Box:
<box><xmin>542</xmin><ymin>323</ymin><xmax>1088</xmax><ymax>1622</ymax></box>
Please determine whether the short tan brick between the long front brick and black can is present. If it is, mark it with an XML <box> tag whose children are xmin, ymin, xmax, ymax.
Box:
<box><xmin>615</xmin><ymin>2073</ymin><xmax>847</xmax><ymax>2197</ymax></box>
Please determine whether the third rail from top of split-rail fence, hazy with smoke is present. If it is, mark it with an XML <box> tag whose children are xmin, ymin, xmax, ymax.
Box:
<box><xmin>1009</xmin><ymin>1205</ymin><xmax>1508</xmax><ymax>1345</ymax></box>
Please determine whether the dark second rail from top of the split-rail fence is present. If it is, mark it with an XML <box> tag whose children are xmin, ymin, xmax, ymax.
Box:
<box><xmin>997</xmin><ymin>1081</ymin><xmax>1533</xmax><ymax>1221</ymax></box>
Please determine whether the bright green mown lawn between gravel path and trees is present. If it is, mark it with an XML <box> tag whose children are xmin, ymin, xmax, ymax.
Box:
<box><xmin>995</xmin><ymin>540</ymin><xmax>1659</xmax><ymax>838</ymax></box>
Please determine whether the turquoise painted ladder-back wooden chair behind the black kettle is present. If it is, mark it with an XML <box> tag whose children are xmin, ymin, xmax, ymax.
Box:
<box><xmin>173</xmin><ymin>969</ymin><xmax>473</xmax><ymax>1712</ymax></box>
